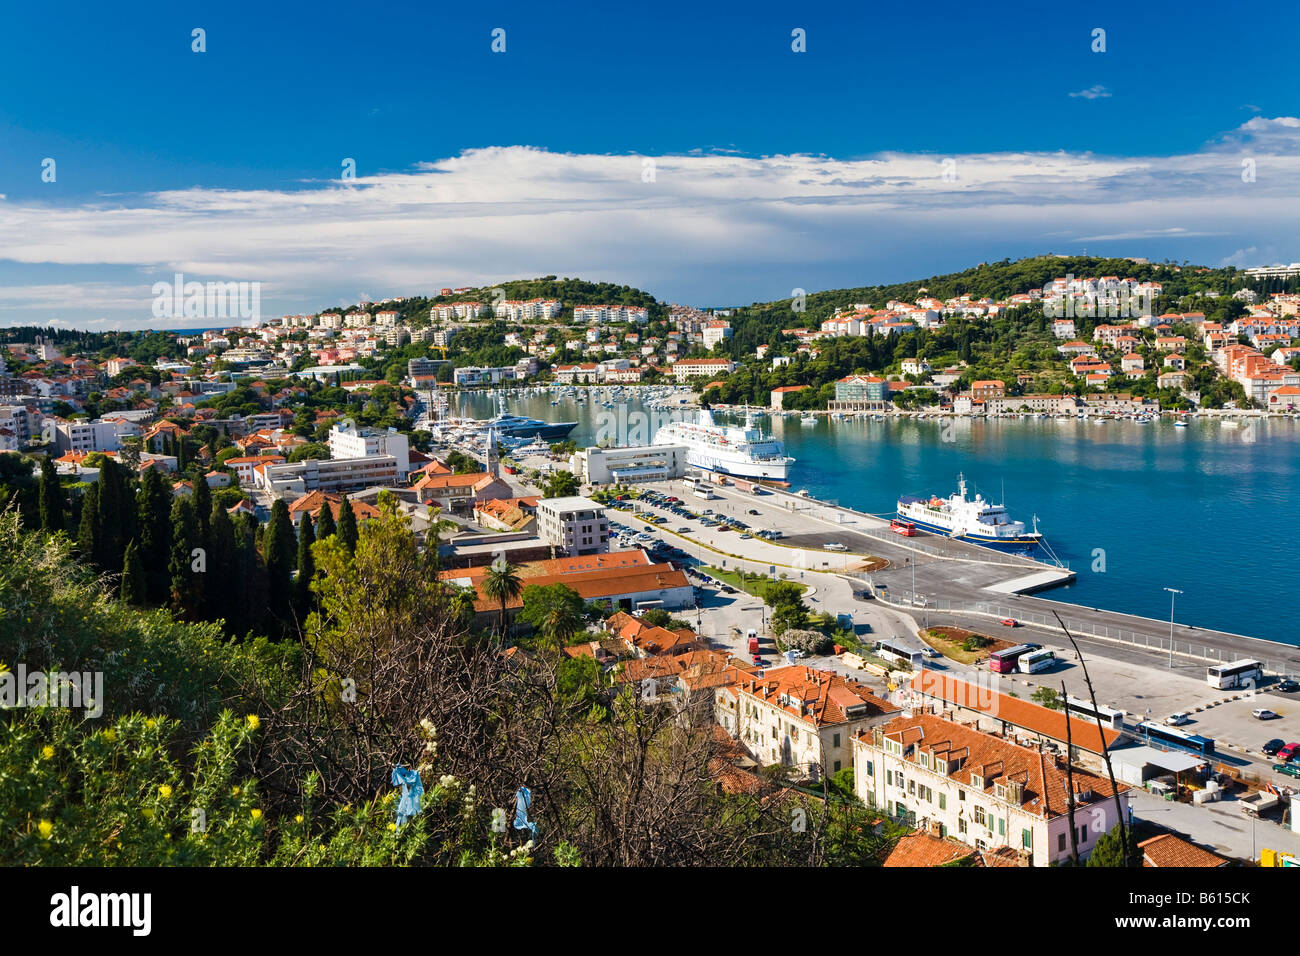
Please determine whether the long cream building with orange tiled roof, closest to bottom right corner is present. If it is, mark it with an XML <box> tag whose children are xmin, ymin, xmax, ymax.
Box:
<box><xmin>853</xmin><ymin>714</ymin><xmax>1128</xmax><ymax>866</ymax></box>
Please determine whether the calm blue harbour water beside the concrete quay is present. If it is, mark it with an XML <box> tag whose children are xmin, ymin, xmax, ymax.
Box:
<box><xmin>464</xmin><ymin>395</ymin><xmax>1300</xmax><ymax>644</ymax></box>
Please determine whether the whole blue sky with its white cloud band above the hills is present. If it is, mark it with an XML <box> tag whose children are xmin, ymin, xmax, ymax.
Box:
<box><xmin>0</xmin><ymin>3</ymin><xmax>1300</xmax><ymax>326</ymax></box>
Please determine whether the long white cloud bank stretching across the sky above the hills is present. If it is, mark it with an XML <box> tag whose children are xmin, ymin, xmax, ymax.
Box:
<box><xmin>0</xmin><ymin>116</ymin><xmax>1300</xmax><ymax>325</ymax></box>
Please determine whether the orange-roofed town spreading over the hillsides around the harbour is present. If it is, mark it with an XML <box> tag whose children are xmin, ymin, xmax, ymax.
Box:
<box><xmin>0</xmin><ymin>261</ymin><xmax>1300</xmax><ymax>868</ymax></box>
